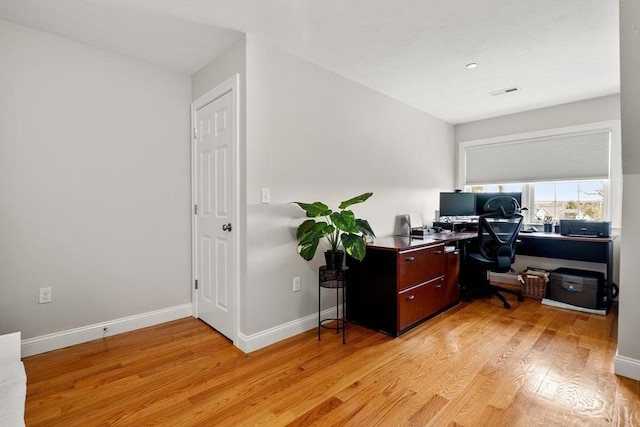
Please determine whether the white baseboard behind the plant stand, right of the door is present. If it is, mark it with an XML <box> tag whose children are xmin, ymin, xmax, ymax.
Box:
<box><xmin>236</xmin><ymin>306</ymin><xmax>344</xmax><ymax>353</ymax></box>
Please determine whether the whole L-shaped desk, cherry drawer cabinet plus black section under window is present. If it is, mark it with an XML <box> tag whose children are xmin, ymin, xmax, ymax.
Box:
<box><xmin>346</xmin><ymin>232</ymin><xmax>616</xmax><ymax>337</ymax></box>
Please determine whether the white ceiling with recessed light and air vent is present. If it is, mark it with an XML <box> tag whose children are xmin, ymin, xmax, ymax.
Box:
<box><xmin>0</xmin><ymin>0</ymin><xmax>620</xmax><ymax>124</ymax></box>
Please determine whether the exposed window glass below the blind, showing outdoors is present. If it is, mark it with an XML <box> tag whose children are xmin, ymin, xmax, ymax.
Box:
<box><xmin>465</xmin><ymin>180</ymin><xmax>607</xmax><ymax>223</ymax></box>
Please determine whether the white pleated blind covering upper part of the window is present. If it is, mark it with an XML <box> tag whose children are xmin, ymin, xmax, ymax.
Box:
<box><xmin>465</xmin><ymin>129</ymin><xmax>611</xmax><ymax>185</ymax></box>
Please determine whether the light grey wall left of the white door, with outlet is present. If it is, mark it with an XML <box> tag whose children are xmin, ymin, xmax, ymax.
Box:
<box><xmin>0</xmin><ymin>21</ymin><xmax>191</xmax><ymax>339</ymax></box>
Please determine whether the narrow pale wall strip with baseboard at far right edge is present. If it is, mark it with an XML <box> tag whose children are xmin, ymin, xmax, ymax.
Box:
<box><xmin>615</xmin><ymin>0</ymin><xmax>640</xmax><ymax>380</ymax></box>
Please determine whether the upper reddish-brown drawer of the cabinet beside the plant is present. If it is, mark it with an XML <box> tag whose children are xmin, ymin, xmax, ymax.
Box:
<box><xmin>398</xmin><ymin>244</ymin><xmax>445</xmax><ymax>290</ymax></box>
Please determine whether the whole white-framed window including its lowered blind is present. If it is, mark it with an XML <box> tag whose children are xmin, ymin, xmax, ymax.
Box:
<box><xmin>455</xmin><ymin>120</ymin><xmax>622</xmax><ymax>227</ymax></box>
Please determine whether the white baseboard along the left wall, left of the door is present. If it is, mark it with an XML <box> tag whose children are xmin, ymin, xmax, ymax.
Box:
<box><xmin>22</xmin><ymin>303</ymin><xmax>193</xmax><ymax>357</ymax></box>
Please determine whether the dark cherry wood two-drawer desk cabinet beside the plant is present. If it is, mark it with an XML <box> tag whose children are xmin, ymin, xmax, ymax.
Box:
<box><xmin>347</xmin><ymin>237</ymin><xmax>460</xmax><ymax>337</ymax></box>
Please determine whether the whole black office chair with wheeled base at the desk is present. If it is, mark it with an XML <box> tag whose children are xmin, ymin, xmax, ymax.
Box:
<box><xmin>461</xmin><ymin>196</ymin><xmax>524</xmax><ymax>308</ymax></box>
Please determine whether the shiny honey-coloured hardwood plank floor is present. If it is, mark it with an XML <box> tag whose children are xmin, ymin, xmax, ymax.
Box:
<box><xmin>24</xmin><ymin>298</ymin><xmax>640</xmax><ymax>427</ymax></box>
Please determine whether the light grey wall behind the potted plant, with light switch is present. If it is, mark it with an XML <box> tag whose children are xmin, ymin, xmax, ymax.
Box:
<box><xmin>241</xmin><ymin>36</ymin><xmax>454</xmax><ymax>336</ymax></box>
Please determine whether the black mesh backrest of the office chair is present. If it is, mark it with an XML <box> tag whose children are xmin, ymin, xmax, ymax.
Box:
<box><xmin>476</xmin><ymin>196</ymin><xmax>524</xmax><ymax>273</ymax></box>
